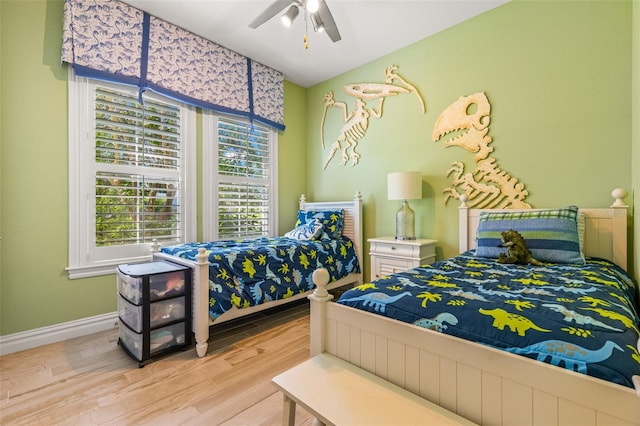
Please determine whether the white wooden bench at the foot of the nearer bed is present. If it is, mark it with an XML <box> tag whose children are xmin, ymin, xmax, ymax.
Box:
<box><xmin>272</xmin><ymin>353</ymin><xmax>474</xmax><ymax>426</ymax></box>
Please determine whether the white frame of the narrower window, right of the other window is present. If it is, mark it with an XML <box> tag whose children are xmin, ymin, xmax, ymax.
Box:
<box><xmin>202</xmin><ymin>111</ymin><xmax>278</xmax><ymax>241</ymax></box>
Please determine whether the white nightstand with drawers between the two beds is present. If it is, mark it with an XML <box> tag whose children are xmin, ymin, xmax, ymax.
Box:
<box><xmin>368</xmin><ymin>237</ymin><xmax>438</xmax><ymax>280</ymax></box>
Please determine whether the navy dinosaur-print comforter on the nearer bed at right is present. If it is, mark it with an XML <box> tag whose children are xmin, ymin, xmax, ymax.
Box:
<box><xmin>338</xmin><ymin>251</ymin><xmax>640</xmax><ymax>387</ymax></box>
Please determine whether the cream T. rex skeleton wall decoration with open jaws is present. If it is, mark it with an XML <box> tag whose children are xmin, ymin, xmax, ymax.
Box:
<box><xmin>433</xmin><ymin>92</ymin><xmax>531</xmax><ymax>208</ymax></box>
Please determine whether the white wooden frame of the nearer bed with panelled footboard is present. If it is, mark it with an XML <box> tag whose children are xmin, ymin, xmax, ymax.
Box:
<box><xmin>309</xmin><ymin>192</ymin><xmax>640</xmax><ymax>426</ymax></box>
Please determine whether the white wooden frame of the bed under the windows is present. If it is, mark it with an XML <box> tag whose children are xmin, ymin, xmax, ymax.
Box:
<box><xmin>152</xmin><ymin>192</ymin><xmax>364</xmax><ymax>357</ymax></box>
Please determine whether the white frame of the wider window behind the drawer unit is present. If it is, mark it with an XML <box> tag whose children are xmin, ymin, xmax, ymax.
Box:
<box><xmin>67</xmin><ymin>67</ymin><xmax>197</xmax><ymax>279</ymax></box>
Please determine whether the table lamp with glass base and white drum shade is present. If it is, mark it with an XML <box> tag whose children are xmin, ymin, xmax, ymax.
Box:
<box><xmin>387</xmin><ymin>172</ymin><xmax>422</xmax><ymax>240</ymax></box>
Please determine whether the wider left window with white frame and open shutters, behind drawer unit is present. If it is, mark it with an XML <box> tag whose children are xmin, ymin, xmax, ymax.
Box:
<box><xmin>68</xmin><ymin>70</ymin><xmax>195</xmax><ymax>278</ymax></box>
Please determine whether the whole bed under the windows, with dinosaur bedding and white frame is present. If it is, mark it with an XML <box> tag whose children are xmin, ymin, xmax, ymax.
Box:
<box><xmin>152</xmin><ymin>192</ymin><xmax>362</xmax><ymax>357</ymax></box>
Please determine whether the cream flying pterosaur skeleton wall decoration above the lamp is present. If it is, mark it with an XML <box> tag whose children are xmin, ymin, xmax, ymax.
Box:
<box><xmin>320</xmin><ymin>65</ymin><xmax>426</xmax><ymax>169</ymax></box>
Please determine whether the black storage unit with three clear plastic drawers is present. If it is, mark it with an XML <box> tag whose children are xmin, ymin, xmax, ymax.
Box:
<box><xmin>117</xmin><ymin>261</ymin><xmax>191</xmax><ymax>367</ymax></box>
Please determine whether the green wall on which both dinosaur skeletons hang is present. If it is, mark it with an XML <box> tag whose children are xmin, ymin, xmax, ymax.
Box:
<box><xmin>307</xmin><ymin>0</ymin><xmax>632</xmax><ymax>272</ymax></box>
